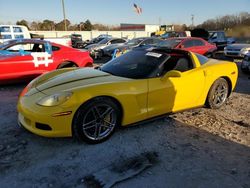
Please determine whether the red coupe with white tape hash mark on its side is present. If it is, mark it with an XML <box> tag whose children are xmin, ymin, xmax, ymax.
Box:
<box><xmin>0</xmin><ymin>39</ymin><xmax>93</xmax><ymax>83</ymax></box>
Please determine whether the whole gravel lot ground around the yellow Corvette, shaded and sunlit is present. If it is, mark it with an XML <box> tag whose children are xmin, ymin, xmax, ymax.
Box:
<box><xmin>0</xmin><ymin>57</ymin><xmax>250</xmax><ymax>188</ymax></box>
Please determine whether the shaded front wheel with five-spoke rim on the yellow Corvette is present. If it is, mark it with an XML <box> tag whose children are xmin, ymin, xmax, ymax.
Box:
<box><xmin>72</xmin><ymin>97</ymin><xmax>121</xmax><ymax>144</ymax></box>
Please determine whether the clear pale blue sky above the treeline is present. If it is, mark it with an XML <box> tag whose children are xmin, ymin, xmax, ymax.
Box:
<box><xmin>0</xmin><ymin>0</ymin><xmax>250</xmax><ymax>25</ymax></box>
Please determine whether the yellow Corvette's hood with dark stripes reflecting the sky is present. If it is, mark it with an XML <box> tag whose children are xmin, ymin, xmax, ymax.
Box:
<box><xmin>32</xmin><ymin>68</ymin><xmax>129</xmax><ymax>94</ymax></box>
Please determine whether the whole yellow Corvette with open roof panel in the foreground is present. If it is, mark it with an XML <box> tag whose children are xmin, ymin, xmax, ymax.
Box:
<box><xmin>18</xmin><ymin>48</ymin><xmax>238</xmax><ymax>143</ymax></box>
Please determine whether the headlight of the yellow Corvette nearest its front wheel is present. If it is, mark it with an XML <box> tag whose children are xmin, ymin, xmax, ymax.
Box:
<box><xmin>37</xmin><ymin>92</ymin><xmax>73</xmax><ymax>106</ymax></box>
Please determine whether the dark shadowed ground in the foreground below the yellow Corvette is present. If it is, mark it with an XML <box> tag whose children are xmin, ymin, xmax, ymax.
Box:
<box><xmin>0</xmin><ymin>117</ymin><xmax>250</xmax><ymax>188</ymax></box>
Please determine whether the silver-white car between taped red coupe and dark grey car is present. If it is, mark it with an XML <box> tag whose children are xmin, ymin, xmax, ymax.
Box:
<box><xmin>86</xmin><ymin>38</ymin><xmax>126</xmax><ymax>59</ymax></box>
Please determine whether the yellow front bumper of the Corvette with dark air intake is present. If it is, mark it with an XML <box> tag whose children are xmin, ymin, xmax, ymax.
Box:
<box><xmin>17</xmin><ymin>93</ymin><xmax>73</xmax><ymax>137</ymax></box>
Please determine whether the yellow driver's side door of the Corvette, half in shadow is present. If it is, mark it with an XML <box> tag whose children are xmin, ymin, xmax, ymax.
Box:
<box><xmin>148</xmin><ymin>69</ymin><xmax>205</xmax><ymax>117</ymax></box>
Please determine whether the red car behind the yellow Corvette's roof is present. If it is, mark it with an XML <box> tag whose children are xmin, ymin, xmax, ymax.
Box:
<box><xmin>159</xmin><ymin>37</ymin><xmax>217</xmax><ymax>57</ymax></box>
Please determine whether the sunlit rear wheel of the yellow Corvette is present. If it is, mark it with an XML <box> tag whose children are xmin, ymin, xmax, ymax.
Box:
<box><xmin>206</xmin><ymin>78</ymin><xmax>229</xmax><ymax>109</ymax></box>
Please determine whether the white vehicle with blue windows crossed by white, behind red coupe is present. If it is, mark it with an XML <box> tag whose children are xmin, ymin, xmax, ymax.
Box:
<box><xmin>0</xmin><ymin>25</ymin><xmax>31</xmax><ymax>43</ymax></box>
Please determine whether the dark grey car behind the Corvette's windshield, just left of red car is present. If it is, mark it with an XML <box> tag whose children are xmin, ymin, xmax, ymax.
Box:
<box><xmin>103</xmin><ymin>37</ymin><xmax>162</xmax><ymax>57</ymax></box>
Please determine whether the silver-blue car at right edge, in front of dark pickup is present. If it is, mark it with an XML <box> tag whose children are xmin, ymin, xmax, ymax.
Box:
<box><xmin>224</xmin><ymin>44</ymin><xmax>250</xmax><ymax>58</ymax></box>
